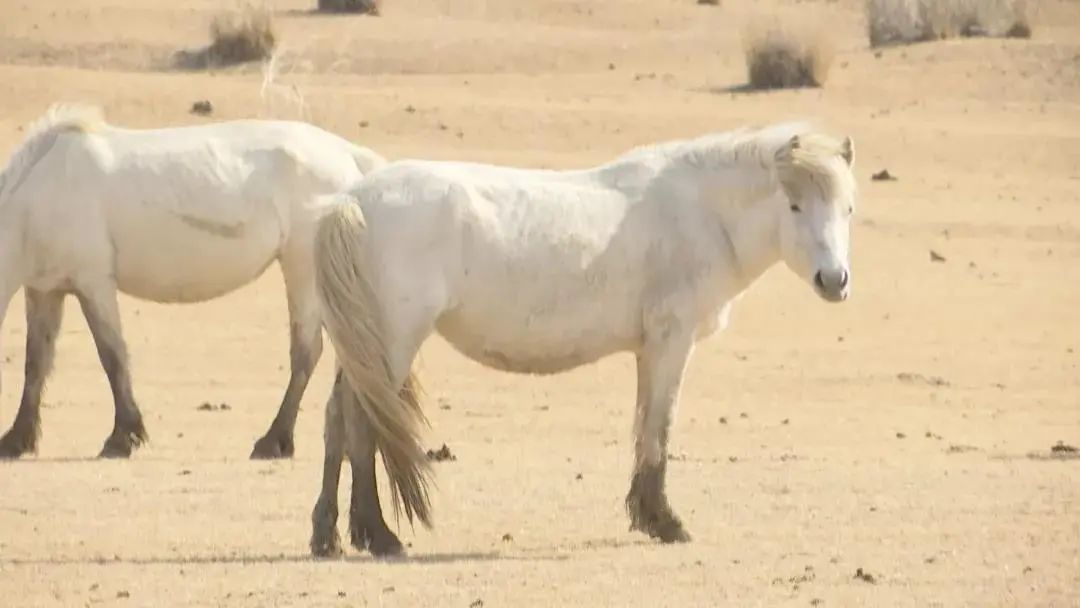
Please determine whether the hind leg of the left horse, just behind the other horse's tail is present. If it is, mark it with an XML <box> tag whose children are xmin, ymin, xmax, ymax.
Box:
<box><xmin>251</xmin><ymin>252</ymin><xmax>323</xmax><ymax>459</ymax></box>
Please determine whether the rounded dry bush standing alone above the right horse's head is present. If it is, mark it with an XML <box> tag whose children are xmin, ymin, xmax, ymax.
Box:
<box><xmin>743</xmin><ymin>21</ymin><xmax>833</xmax><ymax>89</ymax></box>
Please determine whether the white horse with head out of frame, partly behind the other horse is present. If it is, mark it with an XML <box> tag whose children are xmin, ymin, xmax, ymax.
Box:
<box><xmin>0</xmin><ymin>106</ymin><xmax>386</xmax><ymax>458</ymax></box>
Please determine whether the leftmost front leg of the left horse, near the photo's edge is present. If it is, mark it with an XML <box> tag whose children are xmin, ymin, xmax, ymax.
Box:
<box><xmin>0</xmin><ymin>289</ymin><xmax>64</xmax><ymax>458</ymax></box>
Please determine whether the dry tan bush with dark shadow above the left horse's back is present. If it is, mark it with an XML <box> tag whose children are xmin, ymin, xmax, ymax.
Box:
<box><xmin>176</xmin><ymin>4</ymin><xmax>278</xmax><ymax>69</ymax></box>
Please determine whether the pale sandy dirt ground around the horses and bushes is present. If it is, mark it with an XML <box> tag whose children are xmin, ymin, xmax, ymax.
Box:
<box><xmin>0</xmin><ymin>0</ymin><xmax>1080</xmax><ymax>608</ymax></box>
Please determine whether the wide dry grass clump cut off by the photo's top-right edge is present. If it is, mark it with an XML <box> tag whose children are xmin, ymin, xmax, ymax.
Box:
<box><xmin>866</xmin><ymin>0</ymin><xmax>1031</xmax><ymax>46</ymax></box>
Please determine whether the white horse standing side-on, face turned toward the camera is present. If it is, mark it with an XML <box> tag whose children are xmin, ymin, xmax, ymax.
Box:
<box><xmin>311</xmin><ymin>123</ymin><xmax>855</xmax><ymax>555</ymax></box>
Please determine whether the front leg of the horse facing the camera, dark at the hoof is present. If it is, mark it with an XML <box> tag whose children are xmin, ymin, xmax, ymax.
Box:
<box><xmin>626</xmin><ymin>322</ymin><xmax>693</xmax><ymax>542</ymax></box>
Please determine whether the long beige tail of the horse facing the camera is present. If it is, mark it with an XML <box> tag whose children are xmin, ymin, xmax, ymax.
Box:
<box><xmin>314</xmin><ymin>201</ymin><xmax>432</xmax><ymax>528</ymax></box>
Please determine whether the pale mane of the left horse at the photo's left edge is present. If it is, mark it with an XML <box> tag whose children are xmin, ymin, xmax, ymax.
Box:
<box><xmin>0</xmin><ymin>104</ymin><xmax>106</xmax><ymax>206</ymax></box>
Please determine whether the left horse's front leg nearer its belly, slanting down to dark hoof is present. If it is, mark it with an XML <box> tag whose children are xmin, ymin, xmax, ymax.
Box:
<box><xmin>77</xmin><ymin>282</ymin><xmax>148</xmax><ymax>458</ymax></box>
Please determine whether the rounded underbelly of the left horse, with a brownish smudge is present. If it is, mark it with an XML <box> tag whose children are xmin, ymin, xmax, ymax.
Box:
<box><xmin>110</xmin><ymin>211</ymin><xmax>282</xmax><ymax>302</ymax></box>
